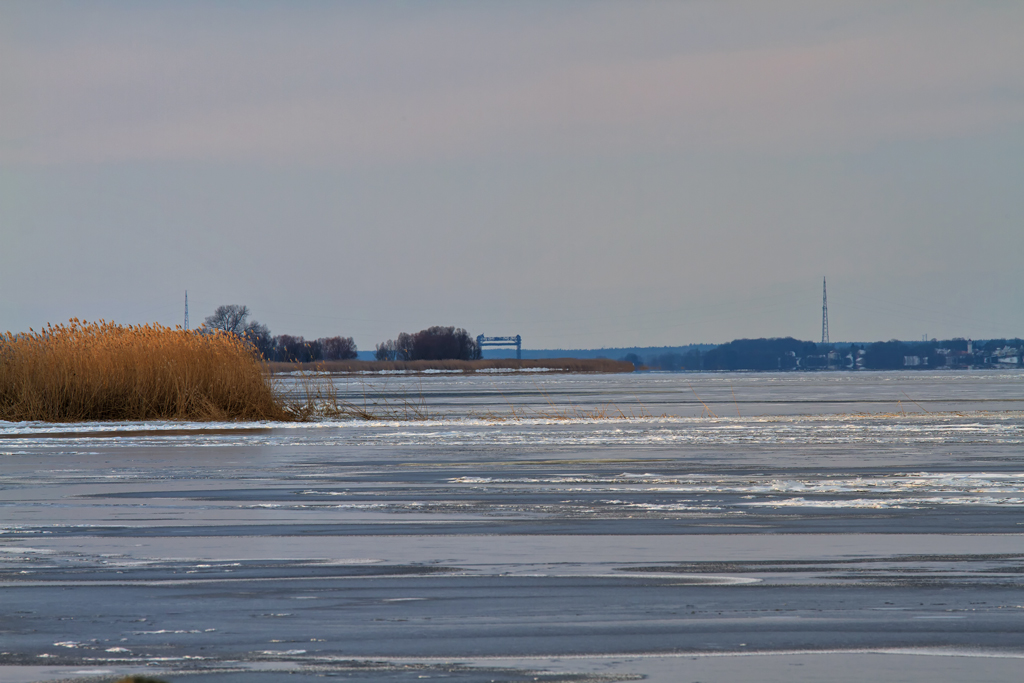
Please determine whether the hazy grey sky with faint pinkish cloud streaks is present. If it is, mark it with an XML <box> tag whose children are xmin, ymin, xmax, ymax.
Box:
<box><xmin>0</xmin><ymin>0</ymin><xmax>1024</xmax><ymax>349</ymax></box>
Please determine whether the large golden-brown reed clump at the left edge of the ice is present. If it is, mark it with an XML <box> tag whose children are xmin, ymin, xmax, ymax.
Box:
<box><xmin>0</xmin><ymin>318</ymin><xmax>294</xmax><ymax>422</ymax></box>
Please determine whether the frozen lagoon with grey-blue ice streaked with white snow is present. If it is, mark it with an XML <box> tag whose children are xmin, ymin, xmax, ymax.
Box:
<box><xmin>0</xmin><ymin>371</ymin><xmax>1024</xmax><ymax>683</ymax></box>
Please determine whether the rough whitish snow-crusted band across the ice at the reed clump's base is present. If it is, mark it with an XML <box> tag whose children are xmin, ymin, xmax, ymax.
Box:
<box><xmin>0</xmin><ymin>412</ymin><xmax>1024</xmax><ymax>452</ymax></box>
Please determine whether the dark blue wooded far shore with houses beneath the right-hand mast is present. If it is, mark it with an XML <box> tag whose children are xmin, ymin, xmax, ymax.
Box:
<box><xmin>621</xmin><ymin>337</ymin><xmax>1024</xmax><ymax>371</ymax></box>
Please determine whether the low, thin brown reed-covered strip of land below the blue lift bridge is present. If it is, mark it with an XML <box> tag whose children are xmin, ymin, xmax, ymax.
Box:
<box><xmin>266</xmin><ymin>358</ymin><xmax>634</xmax><ymax>375</ymax></box>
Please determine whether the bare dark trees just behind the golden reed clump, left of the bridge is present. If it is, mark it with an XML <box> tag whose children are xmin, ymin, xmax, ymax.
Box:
<box><xmin>203</xmin><ymin>304</ymin><xmax>357</xmax><ymax>362</ymax></box>
